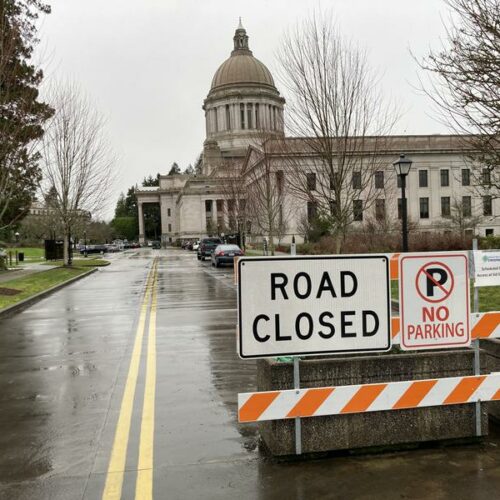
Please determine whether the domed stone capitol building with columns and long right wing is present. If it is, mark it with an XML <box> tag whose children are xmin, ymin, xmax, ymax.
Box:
<box><xmin>136</xmin><ymin>22</ymin><xmax>500</xmax><ymax>245</ymax></box>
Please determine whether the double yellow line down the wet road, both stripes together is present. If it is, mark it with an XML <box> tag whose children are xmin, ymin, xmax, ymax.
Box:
<box><xmin>102</xmin><ymin>259</ymin><xmax>158</xmax><ymax>500</ymax></box>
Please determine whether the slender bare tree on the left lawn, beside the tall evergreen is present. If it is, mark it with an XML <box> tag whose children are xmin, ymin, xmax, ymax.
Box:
<box><xmin>42</xmin><ymin>84</ymin><xmax>114</xmax><ymax>265</ymax></box>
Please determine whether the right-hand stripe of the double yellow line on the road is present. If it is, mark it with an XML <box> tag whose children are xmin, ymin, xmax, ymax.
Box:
<box><xmin>135</xmin><ymin>262</ymin><xmax>157</xmax><ymax>500</ymax></box>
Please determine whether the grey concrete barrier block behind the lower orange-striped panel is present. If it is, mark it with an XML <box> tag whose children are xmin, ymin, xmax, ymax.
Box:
<box><xmin>257</xmin><ymin>349</ymin><xmax>488</xmax><ymax>456</ymax></box>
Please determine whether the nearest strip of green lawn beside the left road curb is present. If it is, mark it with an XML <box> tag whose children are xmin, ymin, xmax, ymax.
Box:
<box><xmin>0</xmin><ymin>267</ymin><xmax>94</xmax><ymax>309</ymax></box>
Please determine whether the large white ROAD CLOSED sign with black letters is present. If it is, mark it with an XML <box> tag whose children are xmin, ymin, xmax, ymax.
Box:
<box><xmin>238</xmin><ymin>255</ymin><xmax>391</xmax><ymax>358</ymax></box>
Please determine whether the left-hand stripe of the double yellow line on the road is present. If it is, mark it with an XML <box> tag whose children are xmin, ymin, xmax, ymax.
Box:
<box><xmin>102</xmin><ymin>261</ymin><xmax>156</xmax><ymax>500</ymax></box>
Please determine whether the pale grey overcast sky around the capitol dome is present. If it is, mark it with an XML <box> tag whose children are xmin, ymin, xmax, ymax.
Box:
<box><xmin>35</xmin><ymin>0</ymin><xmax>447</xmax><ymax>219</ymax></box>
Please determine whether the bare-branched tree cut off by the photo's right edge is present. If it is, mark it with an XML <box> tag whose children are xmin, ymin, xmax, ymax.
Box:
<box><xmin>419</xmin><ymin>0</ymin><xmax>500</xmax><ymax>197</ymax></box>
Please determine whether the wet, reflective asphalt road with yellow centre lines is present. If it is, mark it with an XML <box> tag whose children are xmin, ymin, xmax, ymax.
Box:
<box><xmin>0</xmin><ymin>250</ymin><xmax>500</xmax><ymax>500</ymax></box>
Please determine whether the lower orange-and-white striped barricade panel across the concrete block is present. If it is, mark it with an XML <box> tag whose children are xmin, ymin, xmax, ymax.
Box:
<box><xmin>238</xmin><ymin>373</ymin><xmax>500</xmax><ymax>422</ymax></box>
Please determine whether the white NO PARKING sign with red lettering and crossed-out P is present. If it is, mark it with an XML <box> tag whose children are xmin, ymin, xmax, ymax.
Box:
<box><xmin>399</xmin><ymin>253</ymin><xmax>471</xmax><ymax>350</ymax></box>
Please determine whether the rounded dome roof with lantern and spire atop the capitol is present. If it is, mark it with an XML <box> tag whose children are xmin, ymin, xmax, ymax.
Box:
<box><xmin>211</xmin><ymin>20</ymin><xmax>275</xmax><ymax>90</ymax></box>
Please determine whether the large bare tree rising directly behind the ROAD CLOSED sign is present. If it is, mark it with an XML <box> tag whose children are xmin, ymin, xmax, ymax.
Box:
<box><xmin>278</xmin><ymin>10</ymin><xmax>396</xmax><ymax>252</ymax></box>
